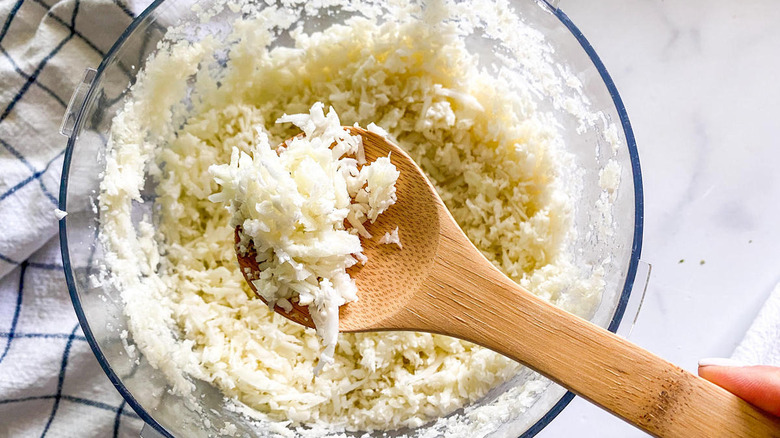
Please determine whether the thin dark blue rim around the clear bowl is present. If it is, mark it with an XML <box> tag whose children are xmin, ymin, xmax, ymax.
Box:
<box><xmin>59</xmin><ymin>0</ymin><xmax>644</xmax><ymax>438</ymax></box>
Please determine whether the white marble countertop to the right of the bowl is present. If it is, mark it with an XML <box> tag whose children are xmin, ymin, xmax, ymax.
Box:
<box><xmin>537</xmin><ymin>0</ymin><xmax>780</xmax><ymax>438</ymax></box>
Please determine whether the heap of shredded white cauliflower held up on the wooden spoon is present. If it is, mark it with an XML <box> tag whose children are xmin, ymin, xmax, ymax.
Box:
<box><xmin>209</xmin><ymin>102</ymin><xmax>399</xmax><ymax>374</ymax></box>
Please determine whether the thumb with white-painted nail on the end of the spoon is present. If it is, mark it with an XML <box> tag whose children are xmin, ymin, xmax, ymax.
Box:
<box><xmin>699</xmin><ymin>359</ymin><xmax>780</xmax><ymax>416</ymax></box>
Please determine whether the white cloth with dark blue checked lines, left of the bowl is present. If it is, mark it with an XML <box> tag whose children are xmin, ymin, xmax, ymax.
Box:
<box><xmin>0</xmin><ymin>0</ymin><xmax>144</xmax><ymax>437</ymax></box>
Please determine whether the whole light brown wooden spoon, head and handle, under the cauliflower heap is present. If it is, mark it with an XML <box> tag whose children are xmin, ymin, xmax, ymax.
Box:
<box><xmin>236</xmin><ymin>128</ymin><xmax>780</xmax><ymax>438</ymax></box>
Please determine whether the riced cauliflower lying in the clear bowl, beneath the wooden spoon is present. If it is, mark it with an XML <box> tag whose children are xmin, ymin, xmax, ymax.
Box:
<box><xmin>100</xmin><ymin>0</ymin><xmax>603</xmax><ymax>431</ymax></box>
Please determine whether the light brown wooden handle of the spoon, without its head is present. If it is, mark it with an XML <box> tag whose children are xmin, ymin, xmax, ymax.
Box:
<box><xmin>406</xmin><ymin>229</ymin><xmax>780</xmax><ymax>438</ymax></box>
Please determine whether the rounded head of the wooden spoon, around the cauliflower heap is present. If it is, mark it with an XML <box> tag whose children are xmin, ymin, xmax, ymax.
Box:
<box><xmin>235</xmin><ymin>127</ymin><xmax>446</xmax><ymax>332</ymax></box>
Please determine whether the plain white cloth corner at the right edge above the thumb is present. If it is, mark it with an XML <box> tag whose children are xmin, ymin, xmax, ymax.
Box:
<box><xmin>732</xmin><ymin>283</ymin><xmax>780</xmax><ymax>366</ymax></box>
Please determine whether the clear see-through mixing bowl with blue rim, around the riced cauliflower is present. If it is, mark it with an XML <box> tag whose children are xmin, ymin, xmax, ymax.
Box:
<box><xmin>59</xmin><ymin>0</ymin><xmax>643</xmax><ymax>437</ymax></box>
